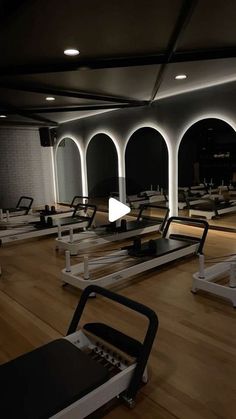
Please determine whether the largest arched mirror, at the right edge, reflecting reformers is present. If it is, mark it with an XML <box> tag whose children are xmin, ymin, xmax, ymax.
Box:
<box><xmin>178</xmin><ymin>118</ymin><xmax>236</xmax><ymax>227</ymax></box>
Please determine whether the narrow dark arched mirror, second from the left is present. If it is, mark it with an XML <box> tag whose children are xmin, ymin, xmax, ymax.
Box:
<box><xmin>86</xmin><ymin>133</ymin><xmax>119</xmax><ymax>209</ymax></box>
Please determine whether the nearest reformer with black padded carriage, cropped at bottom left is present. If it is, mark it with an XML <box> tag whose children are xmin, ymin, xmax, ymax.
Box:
<box><xmin>0</xmin><ymin>285</ymin><xmax>158</xmax><ymax>419</ymax></box>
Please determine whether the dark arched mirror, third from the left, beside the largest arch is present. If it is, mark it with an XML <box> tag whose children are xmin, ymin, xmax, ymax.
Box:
<box><xmin>125</xmin><ymin>126</ymin><xmax>168</xmax><ymax>194</ymax></box>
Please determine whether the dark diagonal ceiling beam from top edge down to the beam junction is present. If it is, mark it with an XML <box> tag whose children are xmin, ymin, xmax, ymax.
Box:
<box><xmin>150</xmin><ymin>0</ymin><xmax>198</xmax><ymax>103</ymax></box>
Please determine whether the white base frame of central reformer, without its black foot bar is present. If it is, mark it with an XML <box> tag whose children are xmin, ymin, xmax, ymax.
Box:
<box><xmin>61</xmin><ymin>243</ymin><xmax>199</xmax><ymax>290</ymax></box>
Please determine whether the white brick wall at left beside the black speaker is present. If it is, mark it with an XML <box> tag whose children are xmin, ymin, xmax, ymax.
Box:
<box><xmin>0</xmin><ymin>128</ymin><xmax>54</xmax><ymax>208</ymax></box>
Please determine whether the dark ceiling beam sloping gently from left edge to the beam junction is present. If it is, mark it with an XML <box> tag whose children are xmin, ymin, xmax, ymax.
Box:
<box><xmin>0</xmin><ymin>82</ymin><xmax>148</xmax><ymax>104</ymax></box>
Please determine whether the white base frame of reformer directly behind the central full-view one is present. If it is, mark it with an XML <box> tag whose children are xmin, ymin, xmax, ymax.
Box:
<box><xmin>55</xmin><ymin>223</ymin><xmax>160</xmax><ymax>256</ymax></box>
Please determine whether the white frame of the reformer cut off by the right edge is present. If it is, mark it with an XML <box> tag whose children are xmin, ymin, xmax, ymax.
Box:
<box><xmin>192</xmin><ymin>255</ymin><xmax>236</xmax><ymax>308</ymax></box>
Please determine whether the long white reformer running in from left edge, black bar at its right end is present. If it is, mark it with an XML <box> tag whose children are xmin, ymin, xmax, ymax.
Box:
<box><xmin>0</xmin><ymin>204</ymin><xmax>97</xmax><ymax>245</ymax></box>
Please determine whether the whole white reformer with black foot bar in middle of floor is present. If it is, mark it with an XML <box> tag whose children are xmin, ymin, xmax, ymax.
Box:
<box><xmin>61</xmin><ymin>217</ymin><xmax>208</xmax><ymax>289</ymax></box>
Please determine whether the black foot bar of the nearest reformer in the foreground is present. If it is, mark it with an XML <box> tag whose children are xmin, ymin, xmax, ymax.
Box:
<box><xmin>67</xmin><ymin>285</ymin><xmax>159</xmax><ymax>399</ymax></box>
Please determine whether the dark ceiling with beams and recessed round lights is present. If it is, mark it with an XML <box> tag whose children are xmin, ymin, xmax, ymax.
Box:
<box><xmin>0</xmin><ymin>0</ymin><xmax>236</xmax><ymax>126</ymax></box>
